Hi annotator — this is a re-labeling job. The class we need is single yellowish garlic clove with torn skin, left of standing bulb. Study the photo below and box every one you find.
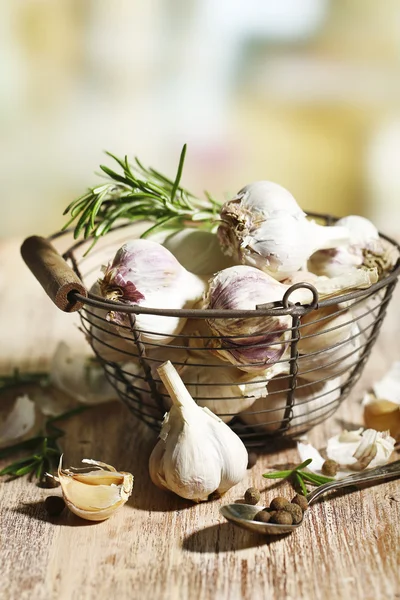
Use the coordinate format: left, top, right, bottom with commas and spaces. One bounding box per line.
55, 457, 133, 521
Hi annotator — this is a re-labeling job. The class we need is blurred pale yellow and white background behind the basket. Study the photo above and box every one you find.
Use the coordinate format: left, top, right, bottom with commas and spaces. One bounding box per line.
0, 0, 400, 237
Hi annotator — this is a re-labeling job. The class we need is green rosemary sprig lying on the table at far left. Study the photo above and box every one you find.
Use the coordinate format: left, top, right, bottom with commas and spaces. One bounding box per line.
0, 406, 90, 482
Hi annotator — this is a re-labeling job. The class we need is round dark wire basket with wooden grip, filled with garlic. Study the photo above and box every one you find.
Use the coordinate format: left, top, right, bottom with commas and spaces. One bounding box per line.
21, 214, 400, 447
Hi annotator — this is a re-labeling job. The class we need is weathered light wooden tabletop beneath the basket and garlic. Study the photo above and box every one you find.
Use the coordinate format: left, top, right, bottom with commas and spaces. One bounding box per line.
0, 240, 400, 600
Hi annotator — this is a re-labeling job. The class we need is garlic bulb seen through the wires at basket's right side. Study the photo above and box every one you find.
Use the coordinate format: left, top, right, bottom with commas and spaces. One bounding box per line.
297, 322, 361, 381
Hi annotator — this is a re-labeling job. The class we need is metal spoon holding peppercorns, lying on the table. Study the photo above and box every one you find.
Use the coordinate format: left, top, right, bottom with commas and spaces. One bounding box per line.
220, 460, 400, 535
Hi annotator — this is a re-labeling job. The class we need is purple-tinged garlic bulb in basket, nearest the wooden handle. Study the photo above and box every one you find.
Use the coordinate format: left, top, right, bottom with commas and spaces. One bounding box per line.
99, 239, 205, 344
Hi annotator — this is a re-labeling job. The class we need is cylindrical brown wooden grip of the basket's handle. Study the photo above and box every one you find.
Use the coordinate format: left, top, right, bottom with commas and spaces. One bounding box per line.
21, 235, 88, 312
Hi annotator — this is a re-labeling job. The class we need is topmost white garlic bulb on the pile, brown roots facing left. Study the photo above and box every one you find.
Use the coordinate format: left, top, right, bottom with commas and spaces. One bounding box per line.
218, 181, 350, 281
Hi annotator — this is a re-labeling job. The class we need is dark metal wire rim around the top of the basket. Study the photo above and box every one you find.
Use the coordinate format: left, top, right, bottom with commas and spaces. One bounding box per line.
48, 212, 400, 319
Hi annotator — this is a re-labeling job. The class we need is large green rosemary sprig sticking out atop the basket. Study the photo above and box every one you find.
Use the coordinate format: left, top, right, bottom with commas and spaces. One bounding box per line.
63, 144, 220, 254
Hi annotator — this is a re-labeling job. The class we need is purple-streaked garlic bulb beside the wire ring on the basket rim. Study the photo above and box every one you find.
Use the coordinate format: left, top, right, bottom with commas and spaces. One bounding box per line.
204, 265, 377, 371
